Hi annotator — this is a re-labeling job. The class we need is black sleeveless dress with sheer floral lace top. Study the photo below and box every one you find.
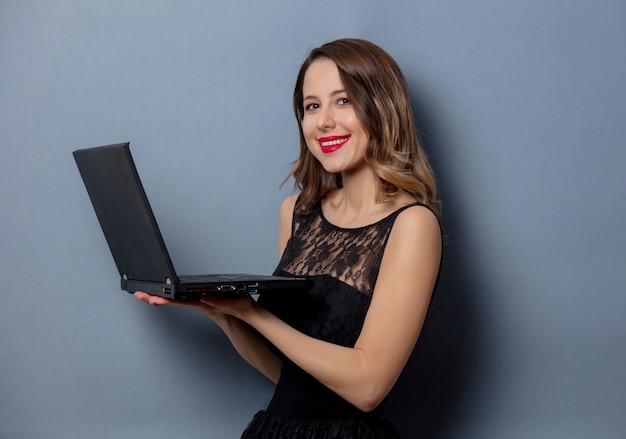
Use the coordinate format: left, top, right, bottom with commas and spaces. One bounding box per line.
241, 203, 421, 439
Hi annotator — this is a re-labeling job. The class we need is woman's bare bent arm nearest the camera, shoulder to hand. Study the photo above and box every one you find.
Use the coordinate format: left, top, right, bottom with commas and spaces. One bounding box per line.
203, 203, 441, 411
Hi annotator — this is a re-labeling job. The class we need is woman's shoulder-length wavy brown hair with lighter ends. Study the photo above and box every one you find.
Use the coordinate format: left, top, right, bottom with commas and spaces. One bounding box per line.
285, 38, 439, 217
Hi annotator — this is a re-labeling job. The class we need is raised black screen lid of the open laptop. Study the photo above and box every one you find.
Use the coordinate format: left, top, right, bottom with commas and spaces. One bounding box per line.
73, 143, 178, 283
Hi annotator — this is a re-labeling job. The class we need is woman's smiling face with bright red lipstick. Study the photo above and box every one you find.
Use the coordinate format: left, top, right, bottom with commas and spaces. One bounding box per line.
302, 59, 369, 174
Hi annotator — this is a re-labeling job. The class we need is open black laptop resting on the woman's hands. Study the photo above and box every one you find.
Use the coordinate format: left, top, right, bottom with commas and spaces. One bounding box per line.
73, 143, 312, 300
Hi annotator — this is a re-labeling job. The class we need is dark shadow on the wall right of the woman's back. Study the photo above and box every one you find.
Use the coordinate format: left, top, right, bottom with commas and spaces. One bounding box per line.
386, 87, 481, 438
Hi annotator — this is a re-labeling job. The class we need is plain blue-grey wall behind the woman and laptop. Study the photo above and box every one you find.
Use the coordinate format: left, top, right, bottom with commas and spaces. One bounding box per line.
0, 0, 626, 439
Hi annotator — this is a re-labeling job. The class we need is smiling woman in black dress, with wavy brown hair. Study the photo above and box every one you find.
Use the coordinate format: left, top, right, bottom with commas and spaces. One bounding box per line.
135, 39, 442, 439
